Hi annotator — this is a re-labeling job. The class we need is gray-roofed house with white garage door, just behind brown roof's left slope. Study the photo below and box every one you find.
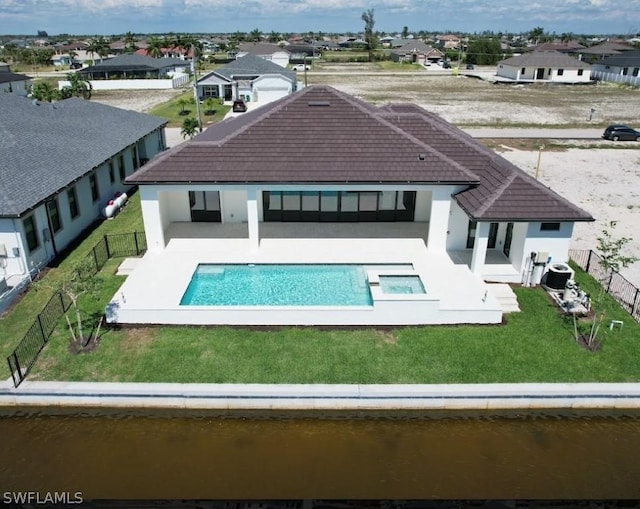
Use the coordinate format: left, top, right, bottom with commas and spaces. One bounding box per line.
196, 55, 299, 104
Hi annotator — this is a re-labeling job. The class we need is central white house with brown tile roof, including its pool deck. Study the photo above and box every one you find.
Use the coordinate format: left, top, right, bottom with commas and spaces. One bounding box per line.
109, 86, 593, 325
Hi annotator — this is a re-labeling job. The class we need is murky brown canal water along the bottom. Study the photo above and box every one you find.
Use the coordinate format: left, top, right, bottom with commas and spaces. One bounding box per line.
0, 409, 640, 499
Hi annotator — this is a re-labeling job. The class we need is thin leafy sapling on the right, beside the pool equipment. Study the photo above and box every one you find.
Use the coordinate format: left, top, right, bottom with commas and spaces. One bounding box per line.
574, 221, 638, 350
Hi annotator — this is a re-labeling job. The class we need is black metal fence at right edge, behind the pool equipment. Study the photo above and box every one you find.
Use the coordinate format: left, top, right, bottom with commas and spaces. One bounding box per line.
569, 249, 640, 322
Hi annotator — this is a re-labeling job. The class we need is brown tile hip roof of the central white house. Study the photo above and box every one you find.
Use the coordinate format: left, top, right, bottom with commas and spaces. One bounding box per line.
127, 86, 593, 221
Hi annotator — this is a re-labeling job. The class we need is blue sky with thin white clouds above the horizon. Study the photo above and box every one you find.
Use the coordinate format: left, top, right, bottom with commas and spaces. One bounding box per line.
0, 0, 640, 35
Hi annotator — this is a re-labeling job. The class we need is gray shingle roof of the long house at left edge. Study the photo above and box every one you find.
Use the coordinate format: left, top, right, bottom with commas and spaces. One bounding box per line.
0, 94, 166, 217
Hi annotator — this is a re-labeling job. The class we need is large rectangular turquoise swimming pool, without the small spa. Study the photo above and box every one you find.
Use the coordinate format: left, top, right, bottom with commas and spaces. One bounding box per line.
180, 264, 373, 306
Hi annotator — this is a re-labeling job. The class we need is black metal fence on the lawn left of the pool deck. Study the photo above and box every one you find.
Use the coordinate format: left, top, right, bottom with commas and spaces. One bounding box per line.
7, 232, 147, 387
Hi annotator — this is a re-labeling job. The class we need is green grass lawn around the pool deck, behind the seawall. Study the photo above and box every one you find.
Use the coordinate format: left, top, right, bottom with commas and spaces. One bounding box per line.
5, 193, 640, 383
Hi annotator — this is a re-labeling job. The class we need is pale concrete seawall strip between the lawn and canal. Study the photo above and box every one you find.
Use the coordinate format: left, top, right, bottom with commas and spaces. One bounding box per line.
0, 379, 640, 411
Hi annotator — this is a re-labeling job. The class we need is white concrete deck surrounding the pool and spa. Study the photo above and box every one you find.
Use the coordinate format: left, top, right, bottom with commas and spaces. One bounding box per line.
108, 223, 504, 326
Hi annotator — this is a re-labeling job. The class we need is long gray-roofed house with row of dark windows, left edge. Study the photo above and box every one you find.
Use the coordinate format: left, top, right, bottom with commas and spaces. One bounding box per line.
0, 94, 166, 308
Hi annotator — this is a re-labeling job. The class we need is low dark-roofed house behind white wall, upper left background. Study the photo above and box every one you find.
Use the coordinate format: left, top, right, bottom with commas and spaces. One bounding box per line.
78, 54, 191, 80
